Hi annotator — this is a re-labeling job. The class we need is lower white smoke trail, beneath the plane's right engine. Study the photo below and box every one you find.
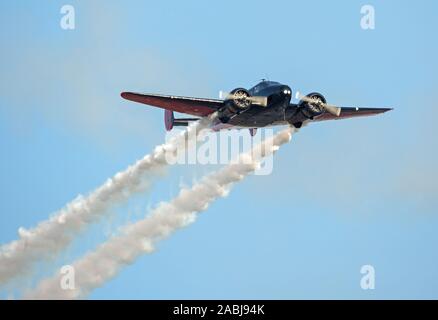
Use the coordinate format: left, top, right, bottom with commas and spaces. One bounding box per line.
24, 128, 295, 299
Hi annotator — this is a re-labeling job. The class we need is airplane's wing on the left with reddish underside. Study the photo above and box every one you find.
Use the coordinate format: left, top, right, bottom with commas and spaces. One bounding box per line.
121, 92, 224, 117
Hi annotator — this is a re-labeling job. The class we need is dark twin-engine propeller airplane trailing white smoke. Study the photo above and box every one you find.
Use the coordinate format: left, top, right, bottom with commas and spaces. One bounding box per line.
121, 79, 392, 136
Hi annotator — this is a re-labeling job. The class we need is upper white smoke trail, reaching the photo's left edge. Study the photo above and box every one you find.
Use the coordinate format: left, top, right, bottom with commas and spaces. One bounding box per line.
0, 115, 214, 285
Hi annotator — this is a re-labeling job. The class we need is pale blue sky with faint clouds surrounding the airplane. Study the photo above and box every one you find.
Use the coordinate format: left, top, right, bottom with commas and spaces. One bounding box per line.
0, 1, 438, 299
